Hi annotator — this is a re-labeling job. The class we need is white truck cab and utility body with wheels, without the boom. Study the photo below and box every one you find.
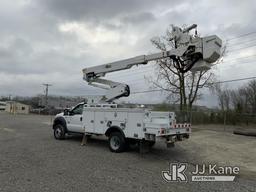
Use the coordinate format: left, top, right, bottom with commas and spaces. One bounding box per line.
53, 103, 191, 152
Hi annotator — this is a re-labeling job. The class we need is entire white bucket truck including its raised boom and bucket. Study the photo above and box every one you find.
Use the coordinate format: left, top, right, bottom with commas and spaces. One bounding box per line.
53, 25, 222, 152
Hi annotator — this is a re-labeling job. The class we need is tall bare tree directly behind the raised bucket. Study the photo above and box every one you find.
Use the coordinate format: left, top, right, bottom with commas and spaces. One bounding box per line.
150, 26, 221, 111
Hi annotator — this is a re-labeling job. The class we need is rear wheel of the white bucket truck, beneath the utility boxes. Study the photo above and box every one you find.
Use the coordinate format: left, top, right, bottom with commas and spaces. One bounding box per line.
108, 132, 126, 153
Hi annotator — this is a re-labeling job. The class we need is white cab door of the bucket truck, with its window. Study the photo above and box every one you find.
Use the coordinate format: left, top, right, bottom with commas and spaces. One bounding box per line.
67, 104, 84, 133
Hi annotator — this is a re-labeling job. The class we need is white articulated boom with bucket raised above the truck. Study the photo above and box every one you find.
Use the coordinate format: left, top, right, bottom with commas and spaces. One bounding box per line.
83, 24, 222, 102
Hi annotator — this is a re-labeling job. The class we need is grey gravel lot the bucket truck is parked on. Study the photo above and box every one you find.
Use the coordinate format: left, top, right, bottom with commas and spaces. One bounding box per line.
0, 113, 256, 192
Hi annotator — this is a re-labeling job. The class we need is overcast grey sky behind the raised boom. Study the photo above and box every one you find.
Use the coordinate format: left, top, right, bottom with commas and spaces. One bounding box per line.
0, 0, 256, 105
